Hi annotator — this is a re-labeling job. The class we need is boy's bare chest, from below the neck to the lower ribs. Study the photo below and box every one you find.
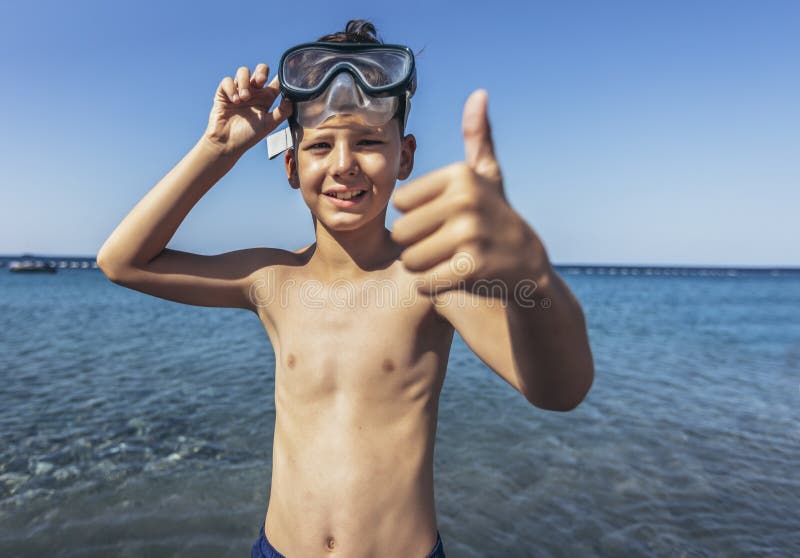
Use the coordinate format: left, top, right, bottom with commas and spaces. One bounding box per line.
253, 270, 453, 402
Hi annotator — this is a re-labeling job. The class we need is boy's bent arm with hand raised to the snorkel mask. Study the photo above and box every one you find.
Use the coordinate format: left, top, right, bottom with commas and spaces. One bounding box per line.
97, 64, 290, 316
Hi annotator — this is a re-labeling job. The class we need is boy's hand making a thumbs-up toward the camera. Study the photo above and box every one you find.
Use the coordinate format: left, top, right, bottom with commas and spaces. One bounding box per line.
392, 90, 550, 294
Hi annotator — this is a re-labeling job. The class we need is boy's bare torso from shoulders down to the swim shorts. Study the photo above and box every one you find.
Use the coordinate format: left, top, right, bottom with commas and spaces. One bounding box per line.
252, 247, 453, 558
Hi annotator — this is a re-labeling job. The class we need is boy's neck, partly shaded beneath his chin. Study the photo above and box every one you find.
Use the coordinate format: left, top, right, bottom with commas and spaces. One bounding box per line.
311, 209, 402, 281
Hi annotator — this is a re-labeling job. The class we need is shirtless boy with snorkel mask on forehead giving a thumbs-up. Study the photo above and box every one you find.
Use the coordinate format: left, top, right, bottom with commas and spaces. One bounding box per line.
97, 20, 593, 558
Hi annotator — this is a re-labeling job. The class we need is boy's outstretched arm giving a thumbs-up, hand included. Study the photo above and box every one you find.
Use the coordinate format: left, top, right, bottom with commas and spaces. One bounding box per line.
392, 92, 594, 411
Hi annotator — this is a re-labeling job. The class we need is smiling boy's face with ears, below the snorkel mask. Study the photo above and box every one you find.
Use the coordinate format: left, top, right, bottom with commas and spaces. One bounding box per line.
284, 114, 416, 231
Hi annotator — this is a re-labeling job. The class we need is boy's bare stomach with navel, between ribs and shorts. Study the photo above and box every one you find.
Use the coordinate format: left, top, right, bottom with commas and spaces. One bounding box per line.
265, 397, 444, 556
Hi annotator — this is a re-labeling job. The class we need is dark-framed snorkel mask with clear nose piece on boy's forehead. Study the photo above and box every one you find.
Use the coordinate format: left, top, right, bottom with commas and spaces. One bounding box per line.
267, 42, 417, 159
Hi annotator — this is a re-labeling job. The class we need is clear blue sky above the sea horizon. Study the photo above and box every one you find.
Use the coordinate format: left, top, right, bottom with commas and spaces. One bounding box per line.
0, 0, 800, 265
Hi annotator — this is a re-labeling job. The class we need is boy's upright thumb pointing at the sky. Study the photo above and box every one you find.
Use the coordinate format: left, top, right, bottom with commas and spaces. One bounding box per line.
461, 89, 500, 180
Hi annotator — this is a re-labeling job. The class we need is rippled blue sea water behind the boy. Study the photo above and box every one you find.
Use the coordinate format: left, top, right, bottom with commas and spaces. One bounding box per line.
0, 269, 800, 558
